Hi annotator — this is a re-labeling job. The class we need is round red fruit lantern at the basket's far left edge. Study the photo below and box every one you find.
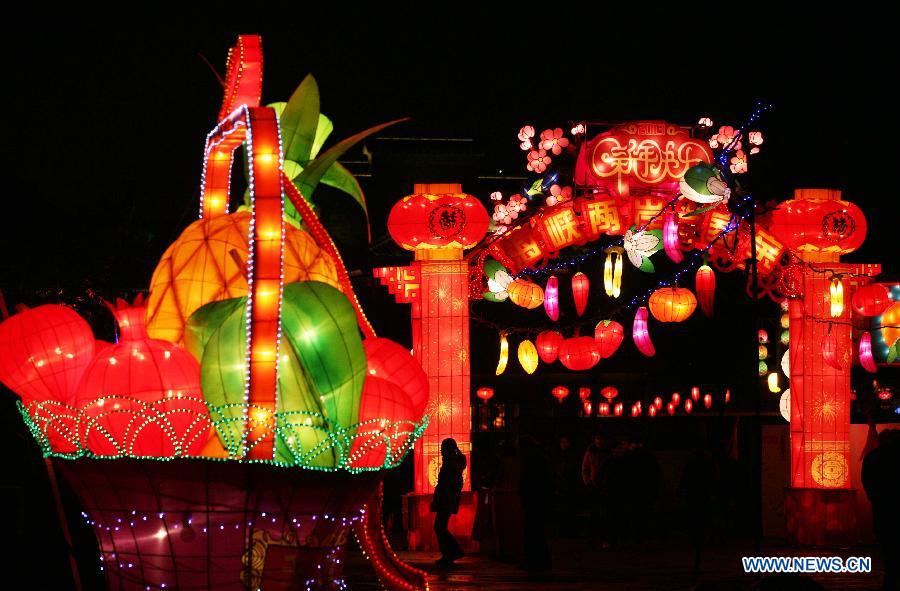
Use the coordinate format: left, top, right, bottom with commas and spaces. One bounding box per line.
0, 304, 95, 407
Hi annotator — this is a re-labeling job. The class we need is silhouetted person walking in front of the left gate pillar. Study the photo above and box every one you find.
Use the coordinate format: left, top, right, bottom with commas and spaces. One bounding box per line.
431, 437, 466, 565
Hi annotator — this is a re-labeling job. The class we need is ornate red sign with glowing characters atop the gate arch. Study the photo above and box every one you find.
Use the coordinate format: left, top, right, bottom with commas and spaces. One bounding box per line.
575, 121, 713, 196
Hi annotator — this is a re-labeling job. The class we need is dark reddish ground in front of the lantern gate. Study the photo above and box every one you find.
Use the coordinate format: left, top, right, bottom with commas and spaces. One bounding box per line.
346, 540, 881, 591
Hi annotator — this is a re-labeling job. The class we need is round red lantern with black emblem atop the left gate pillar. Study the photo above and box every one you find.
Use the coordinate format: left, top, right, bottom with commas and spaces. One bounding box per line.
387, 193, 490, 250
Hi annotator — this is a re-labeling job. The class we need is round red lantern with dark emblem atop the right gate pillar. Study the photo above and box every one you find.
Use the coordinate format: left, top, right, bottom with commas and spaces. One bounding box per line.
770, 189, 866, 261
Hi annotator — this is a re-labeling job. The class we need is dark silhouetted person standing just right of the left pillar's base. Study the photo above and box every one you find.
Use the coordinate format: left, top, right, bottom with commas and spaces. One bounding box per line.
519, 435, 552, 570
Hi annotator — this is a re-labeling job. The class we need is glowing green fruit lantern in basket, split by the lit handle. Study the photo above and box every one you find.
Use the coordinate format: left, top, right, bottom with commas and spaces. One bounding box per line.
185, 281, 366, 467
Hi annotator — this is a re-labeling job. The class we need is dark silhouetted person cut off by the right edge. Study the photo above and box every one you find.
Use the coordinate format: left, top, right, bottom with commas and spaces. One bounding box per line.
862, 429, 900, 590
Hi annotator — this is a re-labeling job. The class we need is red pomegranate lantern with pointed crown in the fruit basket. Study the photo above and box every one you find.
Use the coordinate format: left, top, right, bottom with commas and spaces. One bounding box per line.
75, 296, 209, 457
